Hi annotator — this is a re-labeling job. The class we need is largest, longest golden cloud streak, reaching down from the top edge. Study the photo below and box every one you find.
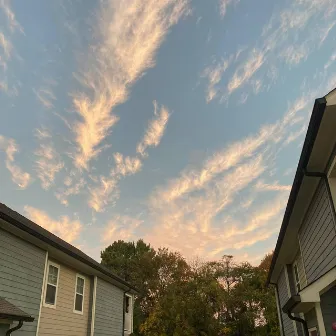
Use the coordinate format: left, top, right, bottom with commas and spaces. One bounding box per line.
73, 0, 188, 168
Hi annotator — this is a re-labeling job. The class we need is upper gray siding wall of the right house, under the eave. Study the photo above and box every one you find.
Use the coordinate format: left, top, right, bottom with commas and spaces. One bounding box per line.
299, 180, 336, 285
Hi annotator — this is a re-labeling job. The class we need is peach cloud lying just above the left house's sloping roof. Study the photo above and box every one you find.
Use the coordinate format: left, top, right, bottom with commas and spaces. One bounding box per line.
24, 205, 83, 243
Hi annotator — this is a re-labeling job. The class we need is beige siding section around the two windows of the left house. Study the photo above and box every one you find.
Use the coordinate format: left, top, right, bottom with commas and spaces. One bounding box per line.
39, 261, 92, 336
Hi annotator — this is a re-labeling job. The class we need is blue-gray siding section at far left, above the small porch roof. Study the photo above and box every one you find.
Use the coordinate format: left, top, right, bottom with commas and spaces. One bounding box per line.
0, 229, 46, 336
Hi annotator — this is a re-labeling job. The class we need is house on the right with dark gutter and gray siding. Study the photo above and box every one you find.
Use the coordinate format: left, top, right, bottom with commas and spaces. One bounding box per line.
268, 89, 336, 336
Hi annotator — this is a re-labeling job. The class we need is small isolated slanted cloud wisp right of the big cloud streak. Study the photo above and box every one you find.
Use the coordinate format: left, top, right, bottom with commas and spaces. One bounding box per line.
137, 101, 170, 156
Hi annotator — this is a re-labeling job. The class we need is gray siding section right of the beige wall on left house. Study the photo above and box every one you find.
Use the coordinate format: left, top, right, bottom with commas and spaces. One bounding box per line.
94, 278, 124, 336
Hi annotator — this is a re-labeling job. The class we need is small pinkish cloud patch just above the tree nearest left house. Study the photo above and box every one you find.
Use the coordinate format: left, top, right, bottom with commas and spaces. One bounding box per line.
101, 215, 143, 244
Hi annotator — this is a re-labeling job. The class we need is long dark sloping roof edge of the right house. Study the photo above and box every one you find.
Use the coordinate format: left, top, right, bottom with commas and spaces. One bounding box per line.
266, 97, 327, 285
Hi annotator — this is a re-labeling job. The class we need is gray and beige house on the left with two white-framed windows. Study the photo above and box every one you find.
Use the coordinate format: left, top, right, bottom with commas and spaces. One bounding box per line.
0, 204, 136, 336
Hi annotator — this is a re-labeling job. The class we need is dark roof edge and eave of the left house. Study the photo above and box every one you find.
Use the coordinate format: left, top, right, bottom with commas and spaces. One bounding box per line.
0, 203, 138, 292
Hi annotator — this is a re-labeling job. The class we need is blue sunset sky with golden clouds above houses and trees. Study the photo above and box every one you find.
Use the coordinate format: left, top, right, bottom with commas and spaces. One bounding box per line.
0, 0, 336, 264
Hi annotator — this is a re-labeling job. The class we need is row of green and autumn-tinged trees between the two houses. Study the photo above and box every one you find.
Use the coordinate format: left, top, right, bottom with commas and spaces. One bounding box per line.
101, 240, 280, 336
